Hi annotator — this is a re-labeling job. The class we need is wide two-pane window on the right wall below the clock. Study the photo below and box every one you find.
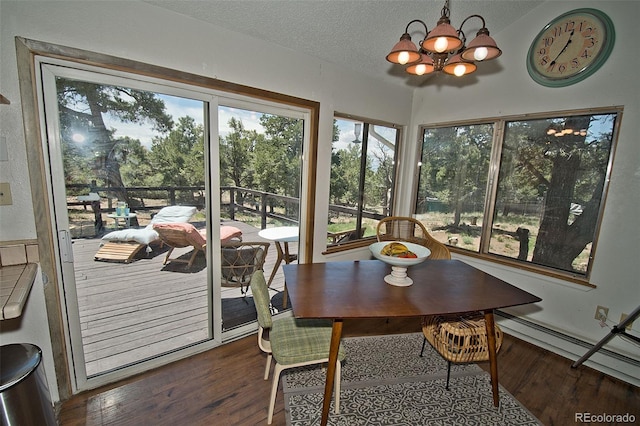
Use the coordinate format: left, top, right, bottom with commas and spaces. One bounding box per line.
414, 108, 622, 282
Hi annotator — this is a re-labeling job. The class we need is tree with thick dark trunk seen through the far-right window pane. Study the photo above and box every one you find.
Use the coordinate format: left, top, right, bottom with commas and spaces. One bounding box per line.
499, 115, 614, 271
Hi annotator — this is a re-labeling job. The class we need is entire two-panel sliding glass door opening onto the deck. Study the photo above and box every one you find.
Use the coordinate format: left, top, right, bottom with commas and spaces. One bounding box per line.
37, 59, 309, 390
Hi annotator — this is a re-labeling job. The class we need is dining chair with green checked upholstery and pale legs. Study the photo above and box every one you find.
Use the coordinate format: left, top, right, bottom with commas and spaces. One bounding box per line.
251, 271, 345, 424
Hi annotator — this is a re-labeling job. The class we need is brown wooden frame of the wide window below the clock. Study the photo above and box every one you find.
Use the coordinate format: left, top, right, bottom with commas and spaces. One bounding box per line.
411, 105, 624, 288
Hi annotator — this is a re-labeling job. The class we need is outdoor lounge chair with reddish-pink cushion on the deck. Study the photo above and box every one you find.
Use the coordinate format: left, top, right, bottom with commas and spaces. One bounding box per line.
153, 223, 242, 268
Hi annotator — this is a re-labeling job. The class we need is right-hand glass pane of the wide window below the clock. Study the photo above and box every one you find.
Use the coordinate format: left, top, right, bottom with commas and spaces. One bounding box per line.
489, 114, 616, 274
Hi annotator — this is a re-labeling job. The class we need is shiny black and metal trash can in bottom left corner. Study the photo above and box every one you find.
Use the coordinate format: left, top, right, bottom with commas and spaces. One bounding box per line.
0, 343, 57, 426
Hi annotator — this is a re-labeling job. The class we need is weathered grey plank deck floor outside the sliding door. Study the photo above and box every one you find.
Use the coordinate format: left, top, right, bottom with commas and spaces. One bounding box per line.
73, 221, 297, 376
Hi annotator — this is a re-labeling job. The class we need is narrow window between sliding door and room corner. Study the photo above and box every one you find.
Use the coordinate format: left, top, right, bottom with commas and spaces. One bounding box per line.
327, 115, 401, 246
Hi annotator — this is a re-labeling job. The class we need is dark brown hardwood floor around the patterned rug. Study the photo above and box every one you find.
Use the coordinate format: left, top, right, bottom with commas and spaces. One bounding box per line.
59, 319, 640, 426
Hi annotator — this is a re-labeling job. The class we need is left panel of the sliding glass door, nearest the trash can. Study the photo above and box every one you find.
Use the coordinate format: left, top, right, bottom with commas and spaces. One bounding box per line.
41, 64, 220, 388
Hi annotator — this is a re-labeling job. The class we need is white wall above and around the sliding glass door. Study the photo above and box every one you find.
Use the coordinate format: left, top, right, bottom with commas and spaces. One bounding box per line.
0, 0, 412, 400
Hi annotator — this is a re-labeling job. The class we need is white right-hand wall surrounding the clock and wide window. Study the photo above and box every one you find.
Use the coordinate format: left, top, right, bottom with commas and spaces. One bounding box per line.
411, 1, 640, 384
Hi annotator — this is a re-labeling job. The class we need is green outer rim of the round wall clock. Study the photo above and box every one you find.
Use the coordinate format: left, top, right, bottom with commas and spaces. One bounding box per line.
527, 8, 616, 87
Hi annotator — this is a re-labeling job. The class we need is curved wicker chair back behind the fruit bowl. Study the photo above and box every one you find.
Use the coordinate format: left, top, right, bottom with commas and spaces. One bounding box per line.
376, 216, 451, 259
